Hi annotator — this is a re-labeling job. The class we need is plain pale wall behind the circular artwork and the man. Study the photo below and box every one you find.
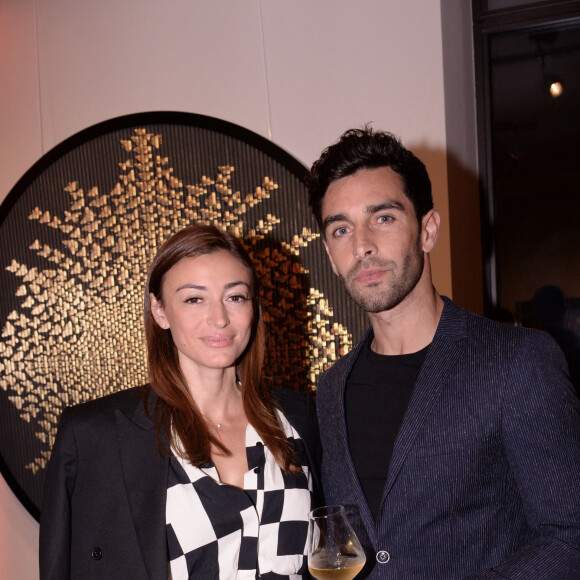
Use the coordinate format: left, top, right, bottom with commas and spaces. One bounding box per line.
0, 0, 473, 579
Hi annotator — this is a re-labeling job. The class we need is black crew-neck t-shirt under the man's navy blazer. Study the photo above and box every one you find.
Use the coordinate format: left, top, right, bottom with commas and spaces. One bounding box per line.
345, 335, 429, 519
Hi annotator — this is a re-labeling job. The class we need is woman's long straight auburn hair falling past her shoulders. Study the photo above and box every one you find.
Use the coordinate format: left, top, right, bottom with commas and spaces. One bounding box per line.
145, 224, 301, 473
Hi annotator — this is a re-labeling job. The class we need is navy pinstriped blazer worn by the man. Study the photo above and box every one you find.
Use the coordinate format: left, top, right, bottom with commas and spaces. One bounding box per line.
317, 298, 580, 580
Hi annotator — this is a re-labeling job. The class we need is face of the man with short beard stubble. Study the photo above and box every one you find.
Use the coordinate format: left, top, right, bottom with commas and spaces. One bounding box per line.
322, 167, 424, 313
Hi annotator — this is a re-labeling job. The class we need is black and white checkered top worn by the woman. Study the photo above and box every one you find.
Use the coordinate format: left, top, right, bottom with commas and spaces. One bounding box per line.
166, 411, 313, 580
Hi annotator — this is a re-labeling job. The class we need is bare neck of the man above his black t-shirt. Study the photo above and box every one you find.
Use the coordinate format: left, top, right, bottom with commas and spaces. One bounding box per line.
369, 286, 444, 355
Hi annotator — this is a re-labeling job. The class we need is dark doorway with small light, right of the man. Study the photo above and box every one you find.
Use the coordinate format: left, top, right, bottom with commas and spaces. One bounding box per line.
474, 1, 580, 390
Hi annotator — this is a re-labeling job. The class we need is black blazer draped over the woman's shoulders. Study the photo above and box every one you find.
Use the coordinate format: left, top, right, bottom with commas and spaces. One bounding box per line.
40, 388, 321, 580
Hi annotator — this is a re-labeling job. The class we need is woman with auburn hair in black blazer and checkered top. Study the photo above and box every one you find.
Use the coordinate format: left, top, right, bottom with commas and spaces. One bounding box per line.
40, 225, 320, 580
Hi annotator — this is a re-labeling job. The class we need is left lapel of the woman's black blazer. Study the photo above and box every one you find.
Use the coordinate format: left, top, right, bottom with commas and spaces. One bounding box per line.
116, 395, 169, 579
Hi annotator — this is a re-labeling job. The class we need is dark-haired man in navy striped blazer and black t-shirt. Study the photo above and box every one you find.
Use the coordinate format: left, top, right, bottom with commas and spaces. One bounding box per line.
309, 127, 580, 580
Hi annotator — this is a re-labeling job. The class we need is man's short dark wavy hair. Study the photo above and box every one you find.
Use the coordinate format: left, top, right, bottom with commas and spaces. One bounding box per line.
307, 125, 433, 233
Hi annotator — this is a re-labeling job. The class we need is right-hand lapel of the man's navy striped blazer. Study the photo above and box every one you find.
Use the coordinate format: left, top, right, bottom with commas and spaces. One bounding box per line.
381, 299, 467, 507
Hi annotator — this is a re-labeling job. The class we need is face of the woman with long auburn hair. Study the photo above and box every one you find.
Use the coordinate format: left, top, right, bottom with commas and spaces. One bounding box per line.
150, 250, 254, 376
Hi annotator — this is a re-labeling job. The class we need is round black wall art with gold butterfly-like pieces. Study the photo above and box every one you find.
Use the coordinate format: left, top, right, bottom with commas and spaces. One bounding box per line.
0, 112, 365, 519
